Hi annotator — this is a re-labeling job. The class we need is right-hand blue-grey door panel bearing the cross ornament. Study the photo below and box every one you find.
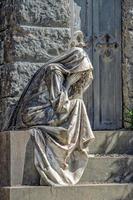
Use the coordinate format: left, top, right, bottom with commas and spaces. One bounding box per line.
93, 0, 122, 129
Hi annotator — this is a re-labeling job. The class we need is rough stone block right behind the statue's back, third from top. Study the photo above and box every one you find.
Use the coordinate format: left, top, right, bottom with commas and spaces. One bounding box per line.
0, 62, 44, 98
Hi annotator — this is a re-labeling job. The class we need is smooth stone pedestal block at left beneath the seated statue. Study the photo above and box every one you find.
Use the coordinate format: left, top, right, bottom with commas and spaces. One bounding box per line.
0, 131, 39, 186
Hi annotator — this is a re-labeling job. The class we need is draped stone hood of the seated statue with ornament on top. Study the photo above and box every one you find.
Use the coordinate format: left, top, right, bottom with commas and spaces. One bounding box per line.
46, 31, 93, 73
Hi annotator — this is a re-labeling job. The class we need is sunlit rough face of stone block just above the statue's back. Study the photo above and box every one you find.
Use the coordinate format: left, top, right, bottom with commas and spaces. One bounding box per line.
13, 26, 70, 62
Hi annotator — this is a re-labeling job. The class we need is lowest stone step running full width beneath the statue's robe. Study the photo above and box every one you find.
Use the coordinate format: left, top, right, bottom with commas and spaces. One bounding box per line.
0, 184, 133, 200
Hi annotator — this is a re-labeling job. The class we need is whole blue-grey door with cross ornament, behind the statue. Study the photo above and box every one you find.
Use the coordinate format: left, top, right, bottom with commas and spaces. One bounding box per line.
72, 0, 122, 130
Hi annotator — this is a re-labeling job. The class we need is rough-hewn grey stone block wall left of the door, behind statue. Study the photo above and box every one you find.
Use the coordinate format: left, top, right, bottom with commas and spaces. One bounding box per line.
0, 0, 71, 129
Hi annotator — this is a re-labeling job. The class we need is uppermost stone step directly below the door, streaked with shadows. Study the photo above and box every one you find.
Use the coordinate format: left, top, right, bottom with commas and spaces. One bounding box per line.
90, 130, 133, 155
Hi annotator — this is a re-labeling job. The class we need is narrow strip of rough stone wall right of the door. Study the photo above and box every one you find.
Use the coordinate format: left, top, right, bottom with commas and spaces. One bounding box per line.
122, 0, 133, 127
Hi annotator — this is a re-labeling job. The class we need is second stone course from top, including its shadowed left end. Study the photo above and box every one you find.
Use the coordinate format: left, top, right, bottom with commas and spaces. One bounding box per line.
0, 26, 71, 64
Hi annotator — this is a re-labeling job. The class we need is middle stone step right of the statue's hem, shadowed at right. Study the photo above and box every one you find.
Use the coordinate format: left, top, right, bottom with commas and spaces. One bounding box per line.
80, 155, 133, 183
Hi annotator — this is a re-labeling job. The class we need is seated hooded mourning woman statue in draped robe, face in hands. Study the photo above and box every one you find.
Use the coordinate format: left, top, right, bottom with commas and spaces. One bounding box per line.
5, 31, 94, 185
